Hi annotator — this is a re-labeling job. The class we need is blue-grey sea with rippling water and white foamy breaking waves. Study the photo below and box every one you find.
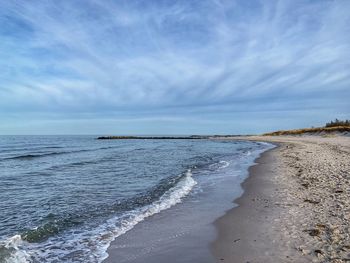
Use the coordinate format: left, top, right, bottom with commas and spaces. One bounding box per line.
0, 136, 273, 262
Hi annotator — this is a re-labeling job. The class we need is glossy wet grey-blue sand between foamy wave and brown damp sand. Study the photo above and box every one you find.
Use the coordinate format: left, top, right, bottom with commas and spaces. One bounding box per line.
103, 141, 273, 263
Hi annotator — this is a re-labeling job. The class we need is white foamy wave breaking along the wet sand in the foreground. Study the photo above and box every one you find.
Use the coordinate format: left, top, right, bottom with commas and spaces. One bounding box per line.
0, 170, 197, 263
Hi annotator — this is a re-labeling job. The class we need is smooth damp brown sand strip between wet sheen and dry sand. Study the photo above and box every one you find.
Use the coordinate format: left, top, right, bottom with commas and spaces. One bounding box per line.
210, 143, 308, 263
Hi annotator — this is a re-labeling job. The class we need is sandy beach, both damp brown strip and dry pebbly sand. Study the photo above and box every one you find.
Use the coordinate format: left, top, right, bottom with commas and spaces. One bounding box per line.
211, 136, 350, 263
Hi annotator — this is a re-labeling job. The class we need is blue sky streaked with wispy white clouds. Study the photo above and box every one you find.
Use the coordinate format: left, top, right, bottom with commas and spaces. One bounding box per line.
0, 0, 350, 135
